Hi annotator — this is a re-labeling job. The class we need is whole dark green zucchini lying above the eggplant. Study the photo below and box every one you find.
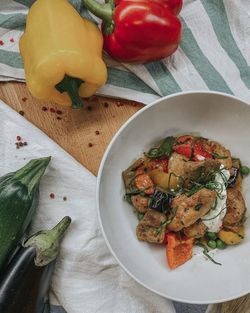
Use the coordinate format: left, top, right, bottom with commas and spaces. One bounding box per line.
0, 157, 51, 272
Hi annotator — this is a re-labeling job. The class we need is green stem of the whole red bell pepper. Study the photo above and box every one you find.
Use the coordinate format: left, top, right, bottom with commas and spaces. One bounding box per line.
82, 0, 114, 34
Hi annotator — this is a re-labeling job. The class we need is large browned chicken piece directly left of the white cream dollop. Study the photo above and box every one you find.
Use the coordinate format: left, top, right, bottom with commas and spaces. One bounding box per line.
167, 188, 217, 231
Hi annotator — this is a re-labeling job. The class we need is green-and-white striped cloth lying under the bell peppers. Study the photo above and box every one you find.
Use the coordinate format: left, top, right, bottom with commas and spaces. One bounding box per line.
0, 0, 250, 104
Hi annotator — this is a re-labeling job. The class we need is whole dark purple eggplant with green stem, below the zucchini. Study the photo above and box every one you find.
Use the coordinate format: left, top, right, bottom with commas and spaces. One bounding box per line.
0, 216, 71, 313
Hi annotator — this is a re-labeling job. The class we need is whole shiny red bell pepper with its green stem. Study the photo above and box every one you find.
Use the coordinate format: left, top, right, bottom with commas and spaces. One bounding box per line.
83, 0, 182, 63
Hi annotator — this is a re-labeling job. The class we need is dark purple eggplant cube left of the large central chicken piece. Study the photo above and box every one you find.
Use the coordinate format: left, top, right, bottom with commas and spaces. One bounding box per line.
149, 190, 172, 213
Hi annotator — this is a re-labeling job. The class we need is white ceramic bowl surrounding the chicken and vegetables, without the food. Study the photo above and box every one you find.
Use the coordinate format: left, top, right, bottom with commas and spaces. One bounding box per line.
97, 92, 250, 304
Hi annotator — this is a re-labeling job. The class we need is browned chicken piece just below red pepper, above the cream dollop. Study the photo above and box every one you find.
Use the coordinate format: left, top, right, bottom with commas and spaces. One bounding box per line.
168, 152, 220, 186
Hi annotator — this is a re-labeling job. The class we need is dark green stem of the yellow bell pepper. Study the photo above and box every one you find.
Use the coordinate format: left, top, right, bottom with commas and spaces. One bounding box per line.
55, 75, 84, 109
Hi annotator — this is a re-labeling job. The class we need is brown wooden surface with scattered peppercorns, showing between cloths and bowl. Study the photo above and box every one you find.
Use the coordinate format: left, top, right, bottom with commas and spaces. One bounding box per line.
0, 82, 250, 313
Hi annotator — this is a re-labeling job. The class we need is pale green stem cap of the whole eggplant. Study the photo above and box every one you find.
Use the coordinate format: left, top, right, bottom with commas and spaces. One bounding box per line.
23, 216, 71, 266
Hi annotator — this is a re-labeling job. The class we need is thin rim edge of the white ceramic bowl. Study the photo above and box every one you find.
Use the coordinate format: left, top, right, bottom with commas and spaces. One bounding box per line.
96, 90, 250, 304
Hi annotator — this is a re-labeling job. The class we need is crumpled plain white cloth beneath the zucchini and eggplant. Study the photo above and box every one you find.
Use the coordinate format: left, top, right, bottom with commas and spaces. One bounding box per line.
0, 101, 175, 313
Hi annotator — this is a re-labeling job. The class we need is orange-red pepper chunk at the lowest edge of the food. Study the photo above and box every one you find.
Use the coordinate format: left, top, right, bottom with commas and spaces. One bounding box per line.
166, 232, 194, 269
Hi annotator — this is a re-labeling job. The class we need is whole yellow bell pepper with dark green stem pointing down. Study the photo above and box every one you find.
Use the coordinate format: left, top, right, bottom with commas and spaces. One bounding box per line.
19, 0, 107, 108
